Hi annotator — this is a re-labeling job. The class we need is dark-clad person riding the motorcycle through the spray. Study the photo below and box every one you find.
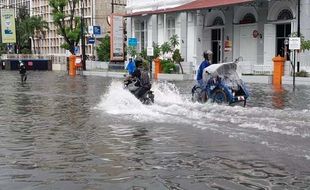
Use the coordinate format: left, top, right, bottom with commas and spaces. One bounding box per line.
131, 59, 152, 99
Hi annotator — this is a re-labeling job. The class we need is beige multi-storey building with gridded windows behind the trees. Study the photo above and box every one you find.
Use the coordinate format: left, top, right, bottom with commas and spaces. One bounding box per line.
0, 0, 126, 63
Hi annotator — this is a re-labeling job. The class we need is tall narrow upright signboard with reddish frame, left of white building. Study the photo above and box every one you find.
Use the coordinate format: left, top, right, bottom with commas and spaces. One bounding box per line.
110, 14, 124, 61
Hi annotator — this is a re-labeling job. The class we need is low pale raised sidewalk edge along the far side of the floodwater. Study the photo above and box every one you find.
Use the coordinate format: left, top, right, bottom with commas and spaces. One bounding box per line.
83, 70, 310, 85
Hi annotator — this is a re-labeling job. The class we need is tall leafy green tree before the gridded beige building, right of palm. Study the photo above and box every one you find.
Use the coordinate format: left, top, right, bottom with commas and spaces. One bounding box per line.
49, 0, 81, 54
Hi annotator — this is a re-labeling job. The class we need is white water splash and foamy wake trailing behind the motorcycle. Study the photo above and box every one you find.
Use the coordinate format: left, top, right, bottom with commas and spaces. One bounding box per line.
96, 81, 310, 160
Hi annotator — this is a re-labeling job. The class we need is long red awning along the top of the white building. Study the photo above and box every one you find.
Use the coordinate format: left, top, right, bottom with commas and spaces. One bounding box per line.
126, 0, 254, 17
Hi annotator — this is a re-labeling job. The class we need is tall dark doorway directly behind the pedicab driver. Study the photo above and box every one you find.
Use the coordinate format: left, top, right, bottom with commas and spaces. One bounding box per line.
211, 28, 222, 64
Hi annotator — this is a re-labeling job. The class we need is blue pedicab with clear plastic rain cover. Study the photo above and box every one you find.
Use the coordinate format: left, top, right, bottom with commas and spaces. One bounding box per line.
192, 61, 249, 106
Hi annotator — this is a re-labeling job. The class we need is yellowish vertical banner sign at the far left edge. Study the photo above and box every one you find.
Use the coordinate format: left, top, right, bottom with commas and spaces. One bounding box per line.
1, 9, 16, 43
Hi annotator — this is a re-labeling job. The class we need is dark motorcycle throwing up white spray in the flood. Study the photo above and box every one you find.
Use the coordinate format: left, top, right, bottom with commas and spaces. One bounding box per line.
124, 77, 154, 105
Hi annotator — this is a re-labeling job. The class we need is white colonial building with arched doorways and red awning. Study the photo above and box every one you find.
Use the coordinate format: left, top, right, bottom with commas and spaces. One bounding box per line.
126, 0, 310, 74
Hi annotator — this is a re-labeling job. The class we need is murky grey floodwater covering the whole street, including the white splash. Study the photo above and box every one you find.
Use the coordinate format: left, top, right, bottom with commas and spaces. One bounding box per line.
0, 71, 310, 190
